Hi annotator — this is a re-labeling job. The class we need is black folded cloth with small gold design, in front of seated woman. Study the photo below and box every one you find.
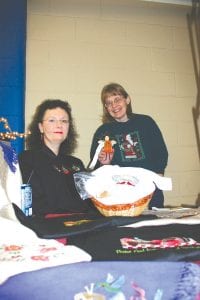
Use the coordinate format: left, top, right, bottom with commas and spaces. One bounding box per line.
13, 204, 157, 239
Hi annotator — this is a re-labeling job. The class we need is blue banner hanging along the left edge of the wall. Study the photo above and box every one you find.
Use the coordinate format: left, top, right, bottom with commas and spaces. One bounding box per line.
0, 0, 27, 153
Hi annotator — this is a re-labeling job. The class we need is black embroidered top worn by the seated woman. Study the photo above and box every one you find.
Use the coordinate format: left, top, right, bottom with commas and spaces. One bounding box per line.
19, 146, 95, 215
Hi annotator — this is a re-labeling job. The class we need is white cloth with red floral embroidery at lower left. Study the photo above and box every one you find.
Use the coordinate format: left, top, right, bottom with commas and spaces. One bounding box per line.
0, 218, 91, 283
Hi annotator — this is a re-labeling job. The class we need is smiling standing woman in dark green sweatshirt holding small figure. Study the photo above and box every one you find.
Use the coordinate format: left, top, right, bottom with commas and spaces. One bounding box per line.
90, 83, 168, 208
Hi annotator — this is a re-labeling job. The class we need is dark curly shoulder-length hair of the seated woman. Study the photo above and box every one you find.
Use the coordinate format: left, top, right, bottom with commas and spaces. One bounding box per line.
25, 99, 78, 155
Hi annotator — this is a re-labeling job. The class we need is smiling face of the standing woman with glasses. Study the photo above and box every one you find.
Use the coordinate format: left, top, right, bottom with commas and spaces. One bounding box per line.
105, 95, 130, 122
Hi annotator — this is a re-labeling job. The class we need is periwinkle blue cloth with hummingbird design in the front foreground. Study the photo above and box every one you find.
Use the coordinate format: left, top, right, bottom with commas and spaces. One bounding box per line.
0, 261, 200, 300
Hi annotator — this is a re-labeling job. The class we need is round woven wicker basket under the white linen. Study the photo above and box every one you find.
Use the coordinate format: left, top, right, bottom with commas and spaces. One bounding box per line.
92, 193, 153, 217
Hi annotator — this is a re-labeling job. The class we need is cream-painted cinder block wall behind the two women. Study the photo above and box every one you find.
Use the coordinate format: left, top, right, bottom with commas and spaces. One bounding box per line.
26, 0, 200, 205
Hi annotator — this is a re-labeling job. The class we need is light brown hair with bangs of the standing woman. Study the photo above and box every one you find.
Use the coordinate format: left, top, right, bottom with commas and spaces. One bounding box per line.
101, 82, 132, 123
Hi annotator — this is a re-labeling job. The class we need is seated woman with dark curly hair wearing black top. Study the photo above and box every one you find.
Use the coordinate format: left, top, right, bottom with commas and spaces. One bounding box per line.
19, 99, 97, 216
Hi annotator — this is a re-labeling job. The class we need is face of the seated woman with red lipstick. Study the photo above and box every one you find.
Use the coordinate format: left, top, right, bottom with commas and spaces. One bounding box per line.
39, 107, 69, 148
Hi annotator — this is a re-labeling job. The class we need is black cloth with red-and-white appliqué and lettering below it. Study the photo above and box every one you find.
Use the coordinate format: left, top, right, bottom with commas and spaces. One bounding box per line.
68, 220, 200, 261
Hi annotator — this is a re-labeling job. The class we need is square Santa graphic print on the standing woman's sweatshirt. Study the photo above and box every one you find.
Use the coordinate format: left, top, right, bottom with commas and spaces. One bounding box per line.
116, 131, 145, 161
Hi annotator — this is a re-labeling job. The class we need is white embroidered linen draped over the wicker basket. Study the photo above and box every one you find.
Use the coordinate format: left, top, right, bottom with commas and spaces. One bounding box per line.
78, 165, 172, 205
